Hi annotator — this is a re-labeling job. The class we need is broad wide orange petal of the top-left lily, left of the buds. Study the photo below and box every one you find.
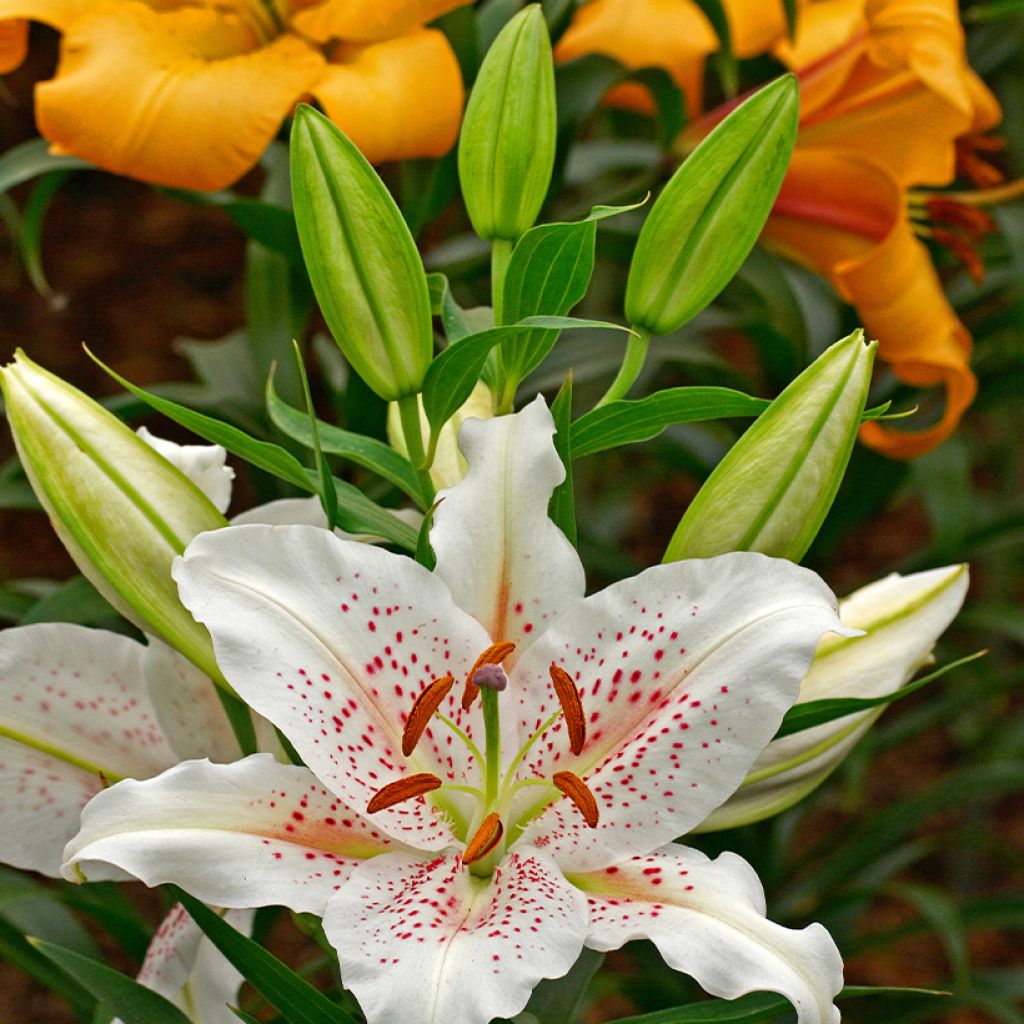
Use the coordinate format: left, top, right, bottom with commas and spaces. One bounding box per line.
36, 3, 324, 189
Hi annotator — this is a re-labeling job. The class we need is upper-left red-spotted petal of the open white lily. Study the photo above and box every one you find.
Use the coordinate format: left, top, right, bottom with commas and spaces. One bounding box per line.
174, 526, 489, 849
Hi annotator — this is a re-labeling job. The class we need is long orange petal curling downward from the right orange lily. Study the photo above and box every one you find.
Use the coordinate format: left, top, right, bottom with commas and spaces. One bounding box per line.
762, 152, 977, 459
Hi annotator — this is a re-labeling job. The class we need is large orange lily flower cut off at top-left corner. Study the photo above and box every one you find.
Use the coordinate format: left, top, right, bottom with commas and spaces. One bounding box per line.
0, 0, 468, 189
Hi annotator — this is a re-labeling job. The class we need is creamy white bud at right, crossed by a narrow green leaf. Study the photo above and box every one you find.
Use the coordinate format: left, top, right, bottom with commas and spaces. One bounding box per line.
697, 565, 968, 831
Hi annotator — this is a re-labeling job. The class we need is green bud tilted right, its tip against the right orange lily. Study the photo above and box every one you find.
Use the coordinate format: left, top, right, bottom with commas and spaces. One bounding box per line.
626, 75, 800, 334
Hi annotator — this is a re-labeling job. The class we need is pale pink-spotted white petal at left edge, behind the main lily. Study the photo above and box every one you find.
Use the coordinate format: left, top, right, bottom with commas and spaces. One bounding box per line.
0, 623, 177, 878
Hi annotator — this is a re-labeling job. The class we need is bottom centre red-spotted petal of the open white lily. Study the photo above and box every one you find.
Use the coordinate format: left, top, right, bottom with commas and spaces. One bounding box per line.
324, 847, 587, 1024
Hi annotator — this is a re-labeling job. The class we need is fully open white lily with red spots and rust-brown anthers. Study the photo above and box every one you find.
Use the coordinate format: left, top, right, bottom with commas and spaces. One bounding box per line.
65, 399, 851, 1024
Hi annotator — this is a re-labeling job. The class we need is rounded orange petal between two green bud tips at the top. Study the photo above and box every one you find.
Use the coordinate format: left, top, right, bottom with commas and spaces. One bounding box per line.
312, 29, 463, 163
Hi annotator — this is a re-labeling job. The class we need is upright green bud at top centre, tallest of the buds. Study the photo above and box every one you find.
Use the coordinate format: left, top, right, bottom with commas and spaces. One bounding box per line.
459, 4, 558, 242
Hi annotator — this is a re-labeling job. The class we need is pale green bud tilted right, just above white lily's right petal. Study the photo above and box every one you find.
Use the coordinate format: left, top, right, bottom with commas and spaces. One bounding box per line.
664, 331, 878, 562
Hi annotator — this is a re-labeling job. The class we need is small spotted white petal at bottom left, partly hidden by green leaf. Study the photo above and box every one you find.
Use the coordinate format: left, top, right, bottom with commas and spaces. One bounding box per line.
114, 903, 255, 1024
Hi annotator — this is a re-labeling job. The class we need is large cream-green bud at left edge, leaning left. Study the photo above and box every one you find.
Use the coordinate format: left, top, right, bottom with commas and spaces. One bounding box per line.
0, 351, 226, 679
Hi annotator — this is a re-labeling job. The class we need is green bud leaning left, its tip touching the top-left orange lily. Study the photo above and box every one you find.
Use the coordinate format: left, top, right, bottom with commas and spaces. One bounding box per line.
292, 106, 433, 400
